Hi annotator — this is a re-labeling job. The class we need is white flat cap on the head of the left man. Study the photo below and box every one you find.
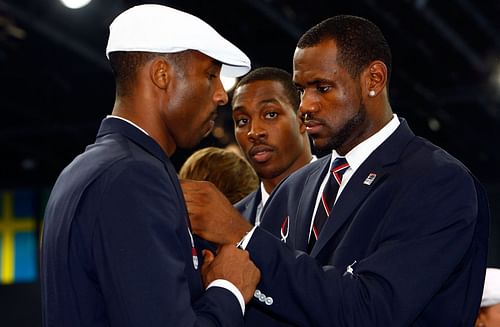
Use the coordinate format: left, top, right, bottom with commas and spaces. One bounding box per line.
106, 4, 251, 77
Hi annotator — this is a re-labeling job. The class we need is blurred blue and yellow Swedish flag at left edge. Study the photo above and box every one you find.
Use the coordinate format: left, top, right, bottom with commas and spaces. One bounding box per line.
0, 190, 38, 284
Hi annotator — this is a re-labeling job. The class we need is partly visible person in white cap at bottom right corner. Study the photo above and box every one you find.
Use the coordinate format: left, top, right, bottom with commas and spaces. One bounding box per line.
475, 267, 500, 327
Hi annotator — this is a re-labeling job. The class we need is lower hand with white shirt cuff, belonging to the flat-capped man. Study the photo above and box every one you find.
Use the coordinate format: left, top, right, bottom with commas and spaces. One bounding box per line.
201, 245, 260, 303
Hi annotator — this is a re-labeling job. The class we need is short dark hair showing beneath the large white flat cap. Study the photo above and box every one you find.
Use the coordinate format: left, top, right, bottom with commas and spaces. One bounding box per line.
109, 51, 187, 96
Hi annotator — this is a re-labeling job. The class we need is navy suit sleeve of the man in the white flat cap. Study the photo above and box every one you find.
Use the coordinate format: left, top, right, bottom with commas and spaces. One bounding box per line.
92, 163, 243, 327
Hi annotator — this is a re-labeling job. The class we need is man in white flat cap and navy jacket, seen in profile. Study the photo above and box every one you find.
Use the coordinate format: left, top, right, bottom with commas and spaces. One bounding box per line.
41, 5, 260, 327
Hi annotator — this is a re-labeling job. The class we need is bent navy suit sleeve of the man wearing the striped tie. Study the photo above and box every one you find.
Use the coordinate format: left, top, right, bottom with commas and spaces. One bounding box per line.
247, 160, 484, 327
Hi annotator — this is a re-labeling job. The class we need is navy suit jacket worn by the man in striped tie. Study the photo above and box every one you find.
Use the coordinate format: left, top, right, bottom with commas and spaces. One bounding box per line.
246, 120, 489, 327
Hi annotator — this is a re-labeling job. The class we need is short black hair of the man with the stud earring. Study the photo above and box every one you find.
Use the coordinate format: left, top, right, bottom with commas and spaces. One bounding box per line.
297, 15, 392, 83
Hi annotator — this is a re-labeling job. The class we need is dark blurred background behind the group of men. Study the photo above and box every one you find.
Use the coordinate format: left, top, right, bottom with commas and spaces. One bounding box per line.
0, 0, 500, 327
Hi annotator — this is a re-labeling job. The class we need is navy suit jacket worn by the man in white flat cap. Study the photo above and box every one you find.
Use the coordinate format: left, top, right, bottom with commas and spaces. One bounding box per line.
41, 118, 243, 327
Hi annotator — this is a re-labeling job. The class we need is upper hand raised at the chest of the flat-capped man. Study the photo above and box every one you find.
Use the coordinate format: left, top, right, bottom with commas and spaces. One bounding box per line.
181, 180, 253, 245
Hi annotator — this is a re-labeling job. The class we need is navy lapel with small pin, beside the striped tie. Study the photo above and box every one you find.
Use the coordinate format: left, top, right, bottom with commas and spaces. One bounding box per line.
311, 120, 415, 257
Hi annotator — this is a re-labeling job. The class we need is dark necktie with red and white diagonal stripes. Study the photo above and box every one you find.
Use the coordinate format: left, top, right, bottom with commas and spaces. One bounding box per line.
307, 157, 349, 253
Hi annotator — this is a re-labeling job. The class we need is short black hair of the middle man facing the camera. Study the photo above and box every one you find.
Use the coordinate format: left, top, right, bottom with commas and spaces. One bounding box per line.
233, 67, 300, 113
